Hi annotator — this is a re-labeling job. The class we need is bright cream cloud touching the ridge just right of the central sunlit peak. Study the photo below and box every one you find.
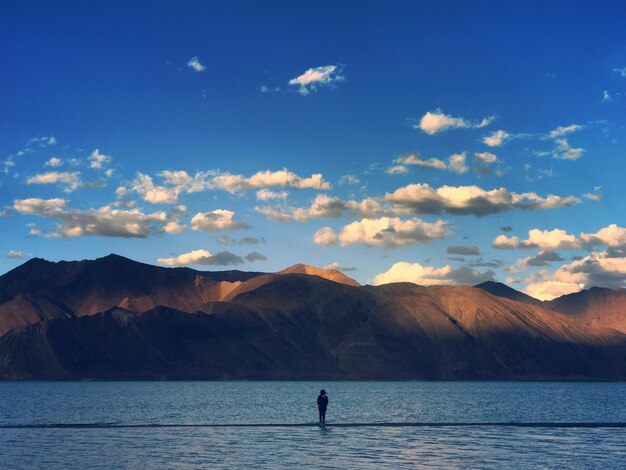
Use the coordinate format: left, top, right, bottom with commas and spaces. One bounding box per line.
374, 261, 494, 286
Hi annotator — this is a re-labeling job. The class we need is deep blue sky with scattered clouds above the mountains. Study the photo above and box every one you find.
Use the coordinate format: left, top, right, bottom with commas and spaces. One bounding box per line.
0, 1, 626, 299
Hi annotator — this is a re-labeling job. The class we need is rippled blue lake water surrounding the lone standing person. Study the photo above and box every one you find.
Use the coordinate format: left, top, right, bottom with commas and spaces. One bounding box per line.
0, 382, 626, 469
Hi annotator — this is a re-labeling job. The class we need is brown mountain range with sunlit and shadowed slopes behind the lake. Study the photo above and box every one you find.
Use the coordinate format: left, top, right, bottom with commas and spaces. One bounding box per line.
0, 255, 626, 380
